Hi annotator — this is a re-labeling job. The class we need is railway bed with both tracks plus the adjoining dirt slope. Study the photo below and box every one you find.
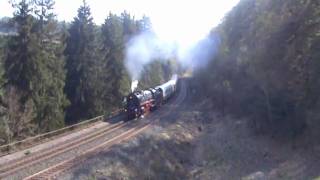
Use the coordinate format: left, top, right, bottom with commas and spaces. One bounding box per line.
0, 78, 320, 179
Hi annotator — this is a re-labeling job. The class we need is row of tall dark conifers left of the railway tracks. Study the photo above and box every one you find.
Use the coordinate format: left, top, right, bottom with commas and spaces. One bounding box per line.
0, 0, 172, 144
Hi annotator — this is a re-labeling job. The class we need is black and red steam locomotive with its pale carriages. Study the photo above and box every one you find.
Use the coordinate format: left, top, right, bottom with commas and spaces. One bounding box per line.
125, 76, 177, 120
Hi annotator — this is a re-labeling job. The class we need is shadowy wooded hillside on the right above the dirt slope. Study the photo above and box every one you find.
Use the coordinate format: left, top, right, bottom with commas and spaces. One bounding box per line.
197, 0, 320, 137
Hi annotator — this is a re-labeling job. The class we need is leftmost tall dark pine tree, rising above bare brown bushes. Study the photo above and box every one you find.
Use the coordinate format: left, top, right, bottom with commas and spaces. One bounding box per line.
5, 0, 37, 95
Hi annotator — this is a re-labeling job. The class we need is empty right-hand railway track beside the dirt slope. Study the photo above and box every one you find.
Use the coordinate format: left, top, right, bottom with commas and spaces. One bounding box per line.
25, 123, 150, 180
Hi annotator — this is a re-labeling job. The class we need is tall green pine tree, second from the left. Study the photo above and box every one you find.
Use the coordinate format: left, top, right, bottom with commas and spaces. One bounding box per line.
33, 0, 68, 131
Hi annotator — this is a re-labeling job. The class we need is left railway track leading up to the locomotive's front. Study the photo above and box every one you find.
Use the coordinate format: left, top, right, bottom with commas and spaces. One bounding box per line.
0, 119, 126, 179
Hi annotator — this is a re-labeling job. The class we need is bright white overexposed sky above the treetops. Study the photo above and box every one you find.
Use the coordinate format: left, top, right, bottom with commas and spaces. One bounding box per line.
0, 0, 239, 45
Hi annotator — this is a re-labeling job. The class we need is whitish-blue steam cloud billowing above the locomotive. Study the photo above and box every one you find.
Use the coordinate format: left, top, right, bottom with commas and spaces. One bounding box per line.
125, 32, 220, 82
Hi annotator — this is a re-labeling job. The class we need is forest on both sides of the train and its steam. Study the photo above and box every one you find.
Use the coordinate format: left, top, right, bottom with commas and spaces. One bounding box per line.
0, 0, 320, 144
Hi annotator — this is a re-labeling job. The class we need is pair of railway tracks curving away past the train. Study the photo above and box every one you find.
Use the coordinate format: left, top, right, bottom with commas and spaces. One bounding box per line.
0, 80, 187, 179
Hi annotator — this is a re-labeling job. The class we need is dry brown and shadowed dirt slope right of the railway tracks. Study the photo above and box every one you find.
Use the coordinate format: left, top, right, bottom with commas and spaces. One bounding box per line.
59, 80, 320, 180
